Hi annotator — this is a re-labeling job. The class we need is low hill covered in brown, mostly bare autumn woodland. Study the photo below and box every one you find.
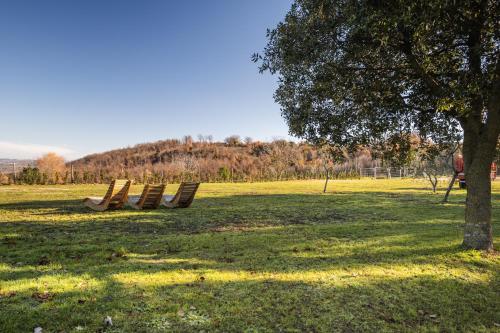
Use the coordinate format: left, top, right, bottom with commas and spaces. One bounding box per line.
67, 136, 372, 183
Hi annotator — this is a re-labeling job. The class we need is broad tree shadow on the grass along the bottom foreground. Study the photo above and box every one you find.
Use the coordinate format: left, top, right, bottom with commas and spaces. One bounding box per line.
0, 268, 498, 332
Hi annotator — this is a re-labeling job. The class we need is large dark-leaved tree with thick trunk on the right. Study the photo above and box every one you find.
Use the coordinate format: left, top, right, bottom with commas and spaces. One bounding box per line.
254, 0, 500, 249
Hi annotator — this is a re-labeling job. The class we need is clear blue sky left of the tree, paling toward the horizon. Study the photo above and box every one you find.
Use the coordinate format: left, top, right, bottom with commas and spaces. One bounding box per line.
0, 0, 291, 158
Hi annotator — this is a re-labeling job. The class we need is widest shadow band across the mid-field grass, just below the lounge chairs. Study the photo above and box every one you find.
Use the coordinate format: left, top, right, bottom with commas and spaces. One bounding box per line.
0, 192, 474, 279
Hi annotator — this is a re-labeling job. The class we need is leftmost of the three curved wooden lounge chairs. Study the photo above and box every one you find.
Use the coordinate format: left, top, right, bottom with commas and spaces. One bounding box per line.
83, 179, 131, 212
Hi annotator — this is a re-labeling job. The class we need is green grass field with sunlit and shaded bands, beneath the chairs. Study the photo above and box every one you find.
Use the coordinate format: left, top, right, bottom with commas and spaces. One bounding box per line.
0, 180, 500, 333
